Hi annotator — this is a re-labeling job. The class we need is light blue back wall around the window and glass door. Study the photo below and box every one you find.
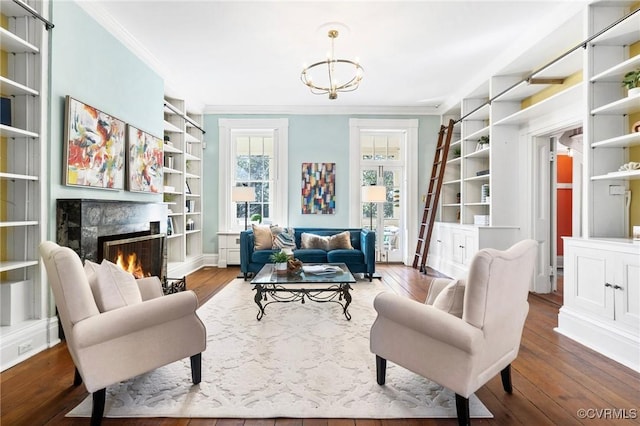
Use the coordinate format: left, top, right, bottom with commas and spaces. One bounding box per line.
203, 115, 440, 253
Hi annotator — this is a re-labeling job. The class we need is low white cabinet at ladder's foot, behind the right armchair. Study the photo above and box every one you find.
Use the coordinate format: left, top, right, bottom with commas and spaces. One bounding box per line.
427, 222, 518, 278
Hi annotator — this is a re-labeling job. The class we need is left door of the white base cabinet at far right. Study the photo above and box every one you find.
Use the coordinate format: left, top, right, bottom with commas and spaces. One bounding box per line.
565, 247, 614, 319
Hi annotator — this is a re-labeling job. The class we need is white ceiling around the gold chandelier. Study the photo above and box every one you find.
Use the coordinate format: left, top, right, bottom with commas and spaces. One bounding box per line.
79, 0, 586, 113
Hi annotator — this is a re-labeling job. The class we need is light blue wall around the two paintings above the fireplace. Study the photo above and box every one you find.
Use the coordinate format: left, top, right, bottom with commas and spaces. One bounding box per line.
48, 1, 164, 238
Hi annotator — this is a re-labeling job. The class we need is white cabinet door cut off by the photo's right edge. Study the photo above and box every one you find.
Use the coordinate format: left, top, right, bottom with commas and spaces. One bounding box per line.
612, 253, 640, 332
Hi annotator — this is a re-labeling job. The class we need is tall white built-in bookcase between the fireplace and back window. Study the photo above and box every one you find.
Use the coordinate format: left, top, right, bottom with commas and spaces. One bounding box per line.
164, 97, 204, 276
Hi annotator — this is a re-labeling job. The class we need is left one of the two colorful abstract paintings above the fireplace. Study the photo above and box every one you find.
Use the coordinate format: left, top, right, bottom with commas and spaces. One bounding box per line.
64, 96, 125, 189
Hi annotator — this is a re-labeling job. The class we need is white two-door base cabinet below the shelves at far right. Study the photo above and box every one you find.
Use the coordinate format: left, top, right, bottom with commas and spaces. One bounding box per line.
556, 238, 640, 371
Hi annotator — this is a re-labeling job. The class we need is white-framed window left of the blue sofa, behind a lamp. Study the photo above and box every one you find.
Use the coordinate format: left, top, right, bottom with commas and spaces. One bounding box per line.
218, 118, 288, 231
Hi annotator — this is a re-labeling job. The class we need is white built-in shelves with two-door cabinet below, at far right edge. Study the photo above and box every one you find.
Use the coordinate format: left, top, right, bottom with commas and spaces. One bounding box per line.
556, 2, 640, 371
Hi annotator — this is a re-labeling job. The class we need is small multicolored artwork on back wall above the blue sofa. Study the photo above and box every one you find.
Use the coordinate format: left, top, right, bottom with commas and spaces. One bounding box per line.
302, 163, 336, 214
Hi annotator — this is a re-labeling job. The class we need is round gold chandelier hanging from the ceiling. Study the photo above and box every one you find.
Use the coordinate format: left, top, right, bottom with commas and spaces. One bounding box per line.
300, 30, 364, 99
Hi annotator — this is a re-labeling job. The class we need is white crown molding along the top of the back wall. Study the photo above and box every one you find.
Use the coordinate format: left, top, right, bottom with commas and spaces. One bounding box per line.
203, 105, 442, 115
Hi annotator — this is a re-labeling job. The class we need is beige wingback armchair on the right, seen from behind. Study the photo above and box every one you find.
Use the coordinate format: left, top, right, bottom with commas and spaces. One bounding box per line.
370, 240, 537, 425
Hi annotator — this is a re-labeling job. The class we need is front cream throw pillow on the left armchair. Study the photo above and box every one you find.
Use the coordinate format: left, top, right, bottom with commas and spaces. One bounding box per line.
89, 259, 142, 312
